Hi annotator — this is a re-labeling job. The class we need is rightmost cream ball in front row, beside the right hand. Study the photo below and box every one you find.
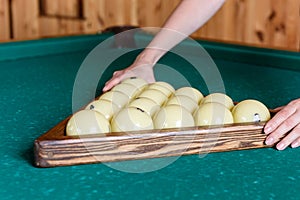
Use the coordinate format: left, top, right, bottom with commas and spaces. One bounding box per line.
232, 99, 271, 123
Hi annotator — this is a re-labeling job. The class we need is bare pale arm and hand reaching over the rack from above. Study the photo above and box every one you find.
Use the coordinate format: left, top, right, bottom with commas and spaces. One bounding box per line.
103, 0, 225, 92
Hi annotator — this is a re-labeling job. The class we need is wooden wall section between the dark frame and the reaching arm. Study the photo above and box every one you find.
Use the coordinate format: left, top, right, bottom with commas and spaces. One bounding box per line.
84, 0, 180, 32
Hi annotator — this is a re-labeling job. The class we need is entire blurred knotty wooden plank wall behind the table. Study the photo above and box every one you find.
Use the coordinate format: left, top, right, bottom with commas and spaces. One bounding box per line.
0, 0, 300, 51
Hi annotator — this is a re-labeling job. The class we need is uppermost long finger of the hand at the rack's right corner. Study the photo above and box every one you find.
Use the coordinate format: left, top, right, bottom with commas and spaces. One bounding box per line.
264, 104, 297, 134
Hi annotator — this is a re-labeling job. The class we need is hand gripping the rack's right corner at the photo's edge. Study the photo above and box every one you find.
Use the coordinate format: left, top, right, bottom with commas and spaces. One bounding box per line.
264, 99, 300, 150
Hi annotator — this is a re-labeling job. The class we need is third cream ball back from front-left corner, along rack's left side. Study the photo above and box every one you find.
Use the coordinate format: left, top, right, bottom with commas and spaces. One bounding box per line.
99, 91, 130, 108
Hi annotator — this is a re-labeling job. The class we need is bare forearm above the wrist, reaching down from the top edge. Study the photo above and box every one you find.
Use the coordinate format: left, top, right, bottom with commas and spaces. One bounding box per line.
136, 0, 225, 65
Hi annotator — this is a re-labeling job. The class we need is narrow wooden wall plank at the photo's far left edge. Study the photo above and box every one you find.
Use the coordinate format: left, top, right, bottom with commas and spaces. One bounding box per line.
0, 0, 10, 40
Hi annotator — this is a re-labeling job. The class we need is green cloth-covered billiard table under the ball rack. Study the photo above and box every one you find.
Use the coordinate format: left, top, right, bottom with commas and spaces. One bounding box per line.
0, 30, 300, 200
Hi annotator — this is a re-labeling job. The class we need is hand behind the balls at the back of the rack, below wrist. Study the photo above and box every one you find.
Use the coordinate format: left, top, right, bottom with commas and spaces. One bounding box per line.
103, 61, 155, 92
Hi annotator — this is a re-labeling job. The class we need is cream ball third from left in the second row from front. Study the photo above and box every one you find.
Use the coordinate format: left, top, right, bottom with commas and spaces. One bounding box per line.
166, 95, 198, 114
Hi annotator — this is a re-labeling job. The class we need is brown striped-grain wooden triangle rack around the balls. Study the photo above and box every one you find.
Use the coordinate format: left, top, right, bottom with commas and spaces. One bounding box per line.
34, 111, 270, 167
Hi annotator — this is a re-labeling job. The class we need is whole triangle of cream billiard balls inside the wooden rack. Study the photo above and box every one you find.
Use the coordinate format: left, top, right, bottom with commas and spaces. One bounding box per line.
66, 77, 270, 135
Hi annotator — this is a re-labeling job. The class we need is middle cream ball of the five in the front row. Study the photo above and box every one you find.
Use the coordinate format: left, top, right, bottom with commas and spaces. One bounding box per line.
153, 105, 195, 129
